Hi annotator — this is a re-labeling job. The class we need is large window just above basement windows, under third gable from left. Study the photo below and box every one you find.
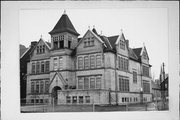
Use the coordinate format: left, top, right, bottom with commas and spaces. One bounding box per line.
119, 76, 129, 92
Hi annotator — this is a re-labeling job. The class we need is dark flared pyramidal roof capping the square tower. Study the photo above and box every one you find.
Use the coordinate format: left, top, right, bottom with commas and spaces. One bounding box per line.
49, 14, 79, 36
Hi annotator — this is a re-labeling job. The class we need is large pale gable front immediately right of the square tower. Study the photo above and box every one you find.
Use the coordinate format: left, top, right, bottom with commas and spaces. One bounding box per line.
76, 29, 106, 53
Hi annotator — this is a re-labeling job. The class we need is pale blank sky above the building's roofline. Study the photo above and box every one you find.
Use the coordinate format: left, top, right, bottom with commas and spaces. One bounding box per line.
19, 8, 168, 79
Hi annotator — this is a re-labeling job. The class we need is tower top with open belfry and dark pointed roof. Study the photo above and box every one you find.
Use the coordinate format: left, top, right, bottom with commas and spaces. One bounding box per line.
49, 11, 79, 50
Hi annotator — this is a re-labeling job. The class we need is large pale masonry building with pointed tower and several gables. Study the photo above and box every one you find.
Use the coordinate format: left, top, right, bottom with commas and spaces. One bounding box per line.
26, 13, 152, 104
